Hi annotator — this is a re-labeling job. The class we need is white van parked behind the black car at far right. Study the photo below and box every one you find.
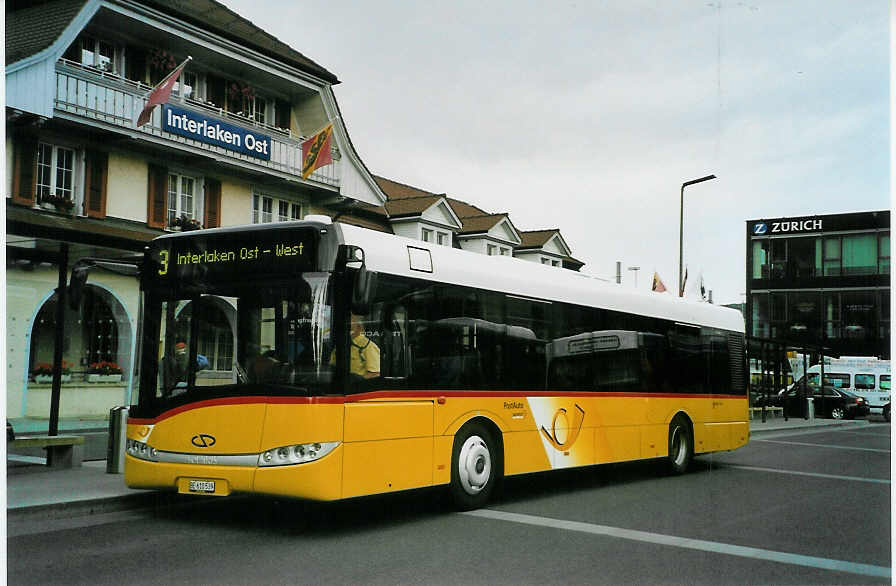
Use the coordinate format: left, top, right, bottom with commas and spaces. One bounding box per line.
788, 356, 890, 421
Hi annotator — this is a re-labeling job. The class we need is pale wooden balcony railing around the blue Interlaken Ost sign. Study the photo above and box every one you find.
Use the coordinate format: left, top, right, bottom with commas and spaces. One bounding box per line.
55, 59, 340, 187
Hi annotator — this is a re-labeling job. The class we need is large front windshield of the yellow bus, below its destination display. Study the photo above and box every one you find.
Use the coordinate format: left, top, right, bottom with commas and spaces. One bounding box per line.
140, 272, 333, 408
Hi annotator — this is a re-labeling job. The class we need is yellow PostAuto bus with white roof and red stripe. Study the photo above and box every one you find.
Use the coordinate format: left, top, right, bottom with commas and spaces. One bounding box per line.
125, 217, 749, 509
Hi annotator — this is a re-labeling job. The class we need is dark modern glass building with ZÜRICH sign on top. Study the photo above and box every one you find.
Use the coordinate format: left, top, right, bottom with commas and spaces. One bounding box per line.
745, 210, 890, 358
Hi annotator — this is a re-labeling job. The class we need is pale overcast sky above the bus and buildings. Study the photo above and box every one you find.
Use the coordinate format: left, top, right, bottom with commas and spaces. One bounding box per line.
223, 0, 891, 303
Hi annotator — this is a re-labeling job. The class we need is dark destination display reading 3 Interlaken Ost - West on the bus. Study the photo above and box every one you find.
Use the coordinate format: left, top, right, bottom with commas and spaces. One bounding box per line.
153, 230, 316, 281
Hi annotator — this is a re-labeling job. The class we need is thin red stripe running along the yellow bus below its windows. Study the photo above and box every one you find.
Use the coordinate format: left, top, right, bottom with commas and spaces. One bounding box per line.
128, 391, 747, 425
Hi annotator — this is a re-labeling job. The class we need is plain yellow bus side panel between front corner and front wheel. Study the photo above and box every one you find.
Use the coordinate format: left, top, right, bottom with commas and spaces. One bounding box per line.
342, 400, 433, 498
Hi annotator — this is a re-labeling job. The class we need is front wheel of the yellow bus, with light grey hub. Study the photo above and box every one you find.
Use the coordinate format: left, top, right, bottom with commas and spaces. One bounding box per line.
451, 421, 499, 511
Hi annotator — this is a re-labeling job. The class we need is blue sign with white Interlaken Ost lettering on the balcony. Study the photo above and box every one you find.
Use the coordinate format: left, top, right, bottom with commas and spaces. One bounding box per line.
162, 104, 271, 161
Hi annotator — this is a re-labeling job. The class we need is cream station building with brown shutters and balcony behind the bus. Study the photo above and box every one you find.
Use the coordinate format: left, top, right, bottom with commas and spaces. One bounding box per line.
5, 0, 582, 431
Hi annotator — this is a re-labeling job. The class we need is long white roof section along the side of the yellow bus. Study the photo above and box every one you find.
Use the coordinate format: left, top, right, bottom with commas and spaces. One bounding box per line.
334, 223, 744, 333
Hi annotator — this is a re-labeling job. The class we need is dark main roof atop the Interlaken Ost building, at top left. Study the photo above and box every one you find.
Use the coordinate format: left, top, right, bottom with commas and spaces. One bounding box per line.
6, 0, 339, 84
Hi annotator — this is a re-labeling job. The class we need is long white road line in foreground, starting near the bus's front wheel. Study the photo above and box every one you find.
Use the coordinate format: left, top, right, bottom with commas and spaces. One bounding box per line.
463, 509, 891, 578
